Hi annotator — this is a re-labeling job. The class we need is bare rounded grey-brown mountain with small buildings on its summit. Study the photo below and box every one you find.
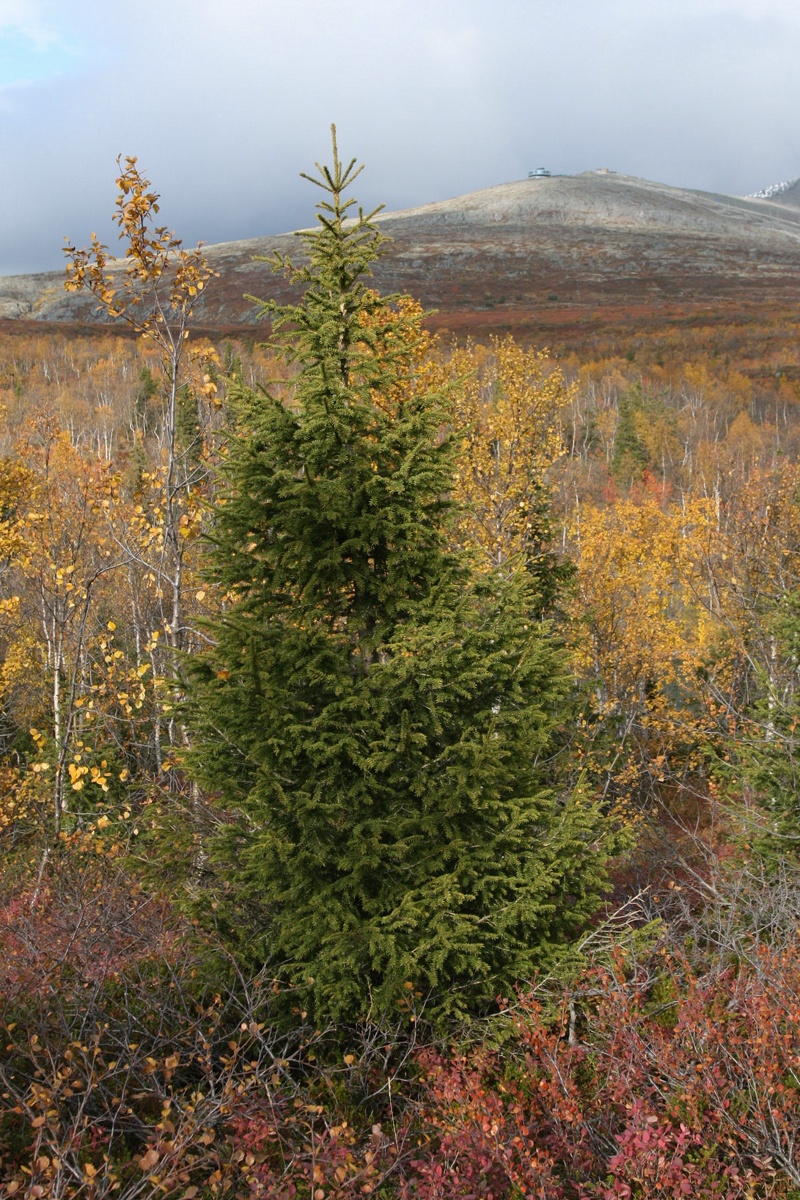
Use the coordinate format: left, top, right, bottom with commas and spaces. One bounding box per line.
0, 169, 800, 328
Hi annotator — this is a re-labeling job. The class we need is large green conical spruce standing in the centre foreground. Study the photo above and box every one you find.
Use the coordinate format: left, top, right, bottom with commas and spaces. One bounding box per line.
188, 132, 604, 1020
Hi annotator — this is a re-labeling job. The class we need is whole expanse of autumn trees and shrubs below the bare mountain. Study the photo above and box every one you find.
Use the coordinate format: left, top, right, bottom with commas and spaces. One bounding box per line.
0, 142, 800, 1200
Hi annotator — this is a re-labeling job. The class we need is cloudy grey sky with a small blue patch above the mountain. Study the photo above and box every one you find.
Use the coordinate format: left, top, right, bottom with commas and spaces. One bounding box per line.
0, 0, 800, 275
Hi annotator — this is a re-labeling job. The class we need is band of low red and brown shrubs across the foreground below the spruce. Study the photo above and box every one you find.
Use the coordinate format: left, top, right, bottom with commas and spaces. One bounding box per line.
9, 847, 800, 1200
